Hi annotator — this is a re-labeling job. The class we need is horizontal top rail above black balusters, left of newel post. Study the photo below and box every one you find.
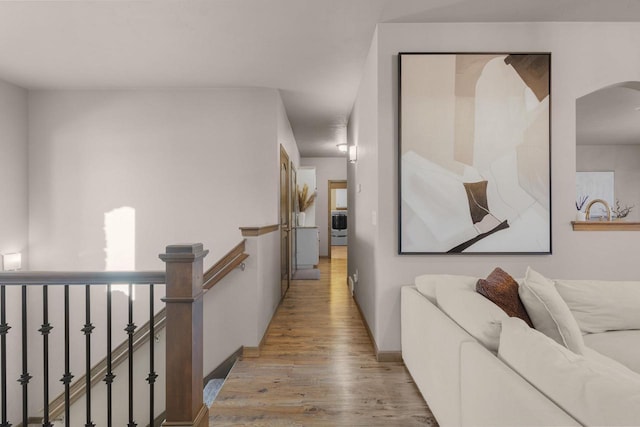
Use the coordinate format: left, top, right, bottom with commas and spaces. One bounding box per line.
0, 271, 166, 286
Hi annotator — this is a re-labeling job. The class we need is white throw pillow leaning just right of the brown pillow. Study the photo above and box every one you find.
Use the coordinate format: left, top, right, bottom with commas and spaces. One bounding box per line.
518, 267, 584, 354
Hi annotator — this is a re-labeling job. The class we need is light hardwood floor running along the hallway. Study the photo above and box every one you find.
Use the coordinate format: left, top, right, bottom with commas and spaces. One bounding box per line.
210, 259, 437, 427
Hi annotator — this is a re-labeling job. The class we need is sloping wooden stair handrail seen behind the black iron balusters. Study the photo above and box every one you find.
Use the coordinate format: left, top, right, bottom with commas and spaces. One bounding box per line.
49, 308, 167, 420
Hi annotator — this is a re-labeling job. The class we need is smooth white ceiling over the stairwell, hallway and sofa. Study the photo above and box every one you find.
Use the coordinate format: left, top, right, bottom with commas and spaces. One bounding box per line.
0, 0, 640, 157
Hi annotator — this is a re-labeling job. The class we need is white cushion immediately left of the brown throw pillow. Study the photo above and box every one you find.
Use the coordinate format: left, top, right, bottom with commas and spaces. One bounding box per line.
436, 276, 509, 352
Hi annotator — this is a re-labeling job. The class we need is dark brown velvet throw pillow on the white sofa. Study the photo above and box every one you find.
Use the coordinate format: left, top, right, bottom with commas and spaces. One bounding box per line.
476, 267, 533, 328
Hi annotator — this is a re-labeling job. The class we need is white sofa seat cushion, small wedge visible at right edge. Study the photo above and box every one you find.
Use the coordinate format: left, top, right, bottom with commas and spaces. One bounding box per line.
584, 330, 640, 374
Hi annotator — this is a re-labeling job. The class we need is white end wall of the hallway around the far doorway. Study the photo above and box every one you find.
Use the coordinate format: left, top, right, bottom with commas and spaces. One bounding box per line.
300, 157, 347, 256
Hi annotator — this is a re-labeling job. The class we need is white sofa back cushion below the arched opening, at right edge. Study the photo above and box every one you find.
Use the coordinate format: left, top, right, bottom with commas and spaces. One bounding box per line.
555, 280, 640, 334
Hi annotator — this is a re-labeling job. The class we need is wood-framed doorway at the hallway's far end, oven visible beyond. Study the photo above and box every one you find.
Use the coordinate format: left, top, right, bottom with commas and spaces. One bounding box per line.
327, 180, 348, 260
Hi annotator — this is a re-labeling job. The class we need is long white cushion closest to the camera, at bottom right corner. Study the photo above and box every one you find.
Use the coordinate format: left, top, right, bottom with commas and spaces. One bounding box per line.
498, 317, 640, 426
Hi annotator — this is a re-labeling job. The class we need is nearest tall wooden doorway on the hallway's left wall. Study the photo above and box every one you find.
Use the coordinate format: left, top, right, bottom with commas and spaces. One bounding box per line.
280, 145, 291, 298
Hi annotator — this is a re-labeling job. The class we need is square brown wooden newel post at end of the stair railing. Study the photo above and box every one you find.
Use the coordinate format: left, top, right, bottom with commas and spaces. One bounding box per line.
160, 243, 209, 427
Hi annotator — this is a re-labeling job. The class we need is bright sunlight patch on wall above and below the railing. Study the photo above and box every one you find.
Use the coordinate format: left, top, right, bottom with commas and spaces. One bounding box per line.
104, 206, 136, 298
